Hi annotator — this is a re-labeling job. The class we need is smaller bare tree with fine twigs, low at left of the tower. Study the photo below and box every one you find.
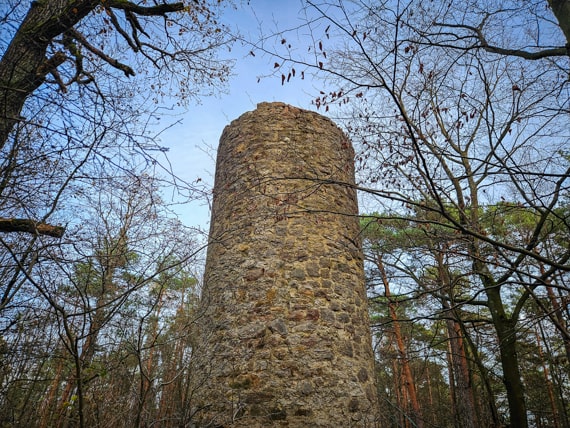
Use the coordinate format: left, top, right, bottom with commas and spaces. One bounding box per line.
0, 169, 201, 426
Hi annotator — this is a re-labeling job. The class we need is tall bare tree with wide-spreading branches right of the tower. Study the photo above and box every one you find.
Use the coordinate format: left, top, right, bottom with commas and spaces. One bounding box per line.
256, 0, 570, 427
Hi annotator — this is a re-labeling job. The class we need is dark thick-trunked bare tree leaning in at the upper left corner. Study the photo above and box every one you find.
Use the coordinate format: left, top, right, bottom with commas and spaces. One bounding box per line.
0, 0, 229, 241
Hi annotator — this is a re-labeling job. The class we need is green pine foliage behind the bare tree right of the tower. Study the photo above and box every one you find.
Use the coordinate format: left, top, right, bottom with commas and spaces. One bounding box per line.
361, 202, 568, 426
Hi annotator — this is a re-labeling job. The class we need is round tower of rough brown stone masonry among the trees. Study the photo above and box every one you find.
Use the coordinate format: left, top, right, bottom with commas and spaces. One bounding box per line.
193, 103, 376, 427
